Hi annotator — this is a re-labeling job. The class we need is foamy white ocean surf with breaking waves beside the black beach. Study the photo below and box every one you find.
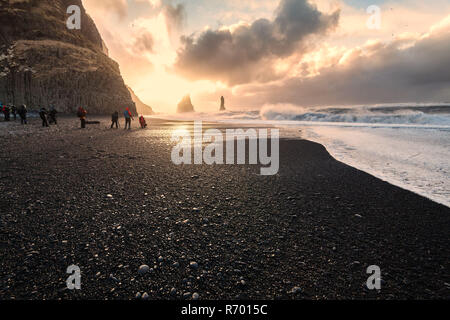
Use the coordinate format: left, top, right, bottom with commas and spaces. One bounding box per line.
150, 103, 450, 207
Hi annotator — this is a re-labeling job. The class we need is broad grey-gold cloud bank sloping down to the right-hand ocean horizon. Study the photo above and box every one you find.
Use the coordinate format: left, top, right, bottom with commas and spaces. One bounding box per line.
234, 15, 450, 106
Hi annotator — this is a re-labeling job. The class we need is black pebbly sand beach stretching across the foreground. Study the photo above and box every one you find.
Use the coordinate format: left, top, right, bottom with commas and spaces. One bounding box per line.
0, 119, 450, 299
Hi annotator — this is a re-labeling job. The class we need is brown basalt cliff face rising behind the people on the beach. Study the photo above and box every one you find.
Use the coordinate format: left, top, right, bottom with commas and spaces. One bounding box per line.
0, 0, 136, 114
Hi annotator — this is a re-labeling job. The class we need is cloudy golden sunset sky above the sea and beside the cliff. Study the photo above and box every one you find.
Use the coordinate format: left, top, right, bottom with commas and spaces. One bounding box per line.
83, 0, 450, 113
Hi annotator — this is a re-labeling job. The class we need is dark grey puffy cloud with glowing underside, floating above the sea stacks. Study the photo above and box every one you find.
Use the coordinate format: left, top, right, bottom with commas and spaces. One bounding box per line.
174, 0, 339, 85
